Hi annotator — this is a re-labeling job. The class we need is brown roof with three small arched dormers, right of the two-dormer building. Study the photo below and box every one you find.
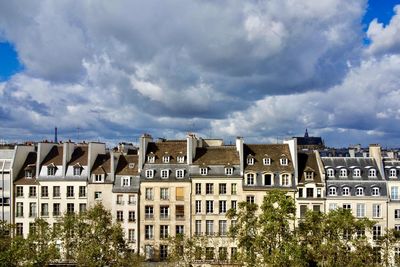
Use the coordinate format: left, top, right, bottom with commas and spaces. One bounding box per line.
243, 144, 294, 172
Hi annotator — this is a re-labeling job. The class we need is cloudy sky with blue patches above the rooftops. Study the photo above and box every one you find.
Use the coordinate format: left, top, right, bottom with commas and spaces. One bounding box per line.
0, 0, 400, 147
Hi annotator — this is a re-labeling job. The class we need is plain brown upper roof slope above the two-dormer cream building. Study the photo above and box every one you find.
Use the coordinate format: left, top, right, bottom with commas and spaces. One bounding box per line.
193, 146, 240, 165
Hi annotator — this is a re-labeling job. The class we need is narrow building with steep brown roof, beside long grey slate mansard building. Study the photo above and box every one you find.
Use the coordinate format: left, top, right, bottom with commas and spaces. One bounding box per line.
296, 151, 325, 219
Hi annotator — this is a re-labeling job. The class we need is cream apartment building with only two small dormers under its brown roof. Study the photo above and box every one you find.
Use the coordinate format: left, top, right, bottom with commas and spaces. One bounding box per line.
188, 136, 243, 263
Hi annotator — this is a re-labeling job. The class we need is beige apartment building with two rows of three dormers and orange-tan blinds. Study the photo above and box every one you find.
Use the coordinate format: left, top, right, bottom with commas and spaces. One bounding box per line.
139, 135, 191, 261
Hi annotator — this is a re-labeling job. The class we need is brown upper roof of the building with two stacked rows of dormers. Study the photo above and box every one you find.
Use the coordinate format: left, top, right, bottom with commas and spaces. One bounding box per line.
146, 140, 187, 164
